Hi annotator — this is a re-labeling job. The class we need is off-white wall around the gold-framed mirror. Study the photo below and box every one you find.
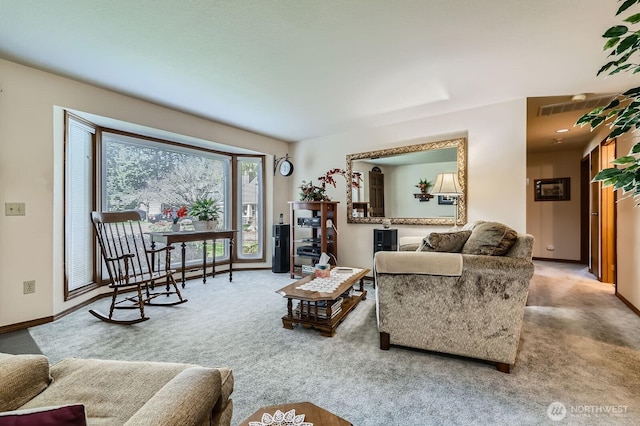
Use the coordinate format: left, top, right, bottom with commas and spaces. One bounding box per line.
291, 99, 526, 268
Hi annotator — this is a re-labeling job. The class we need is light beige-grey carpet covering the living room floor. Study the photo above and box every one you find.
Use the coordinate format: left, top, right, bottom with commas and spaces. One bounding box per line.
30, 262, 640, 426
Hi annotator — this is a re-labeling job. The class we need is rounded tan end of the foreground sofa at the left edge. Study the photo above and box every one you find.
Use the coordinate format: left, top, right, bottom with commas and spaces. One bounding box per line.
0, 354, 51, 411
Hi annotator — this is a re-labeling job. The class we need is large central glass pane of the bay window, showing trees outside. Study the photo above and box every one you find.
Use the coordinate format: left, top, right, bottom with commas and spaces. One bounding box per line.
102, 132, 232, 266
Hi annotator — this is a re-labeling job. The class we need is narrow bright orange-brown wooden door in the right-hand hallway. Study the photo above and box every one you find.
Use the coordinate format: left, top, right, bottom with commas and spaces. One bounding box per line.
600, 140, 616, 284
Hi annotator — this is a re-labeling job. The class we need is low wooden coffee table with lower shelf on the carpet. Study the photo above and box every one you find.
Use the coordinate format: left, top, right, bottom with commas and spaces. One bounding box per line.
277, 268, 369, 337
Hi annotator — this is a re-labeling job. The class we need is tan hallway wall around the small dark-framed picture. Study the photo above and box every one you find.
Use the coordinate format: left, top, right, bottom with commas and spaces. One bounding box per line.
527, 150, 582, 261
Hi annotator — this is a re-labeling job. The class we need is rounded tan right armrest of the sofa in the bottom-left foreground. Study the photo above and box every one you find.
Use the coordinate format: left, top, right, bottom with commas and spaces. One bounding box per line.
125, 367, 222, 426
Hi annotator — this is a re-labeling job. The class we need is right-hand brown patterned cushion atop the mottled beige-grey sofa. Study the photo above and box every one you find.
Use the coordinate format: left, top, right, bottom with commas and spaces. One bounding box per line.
462, 222, 518, 256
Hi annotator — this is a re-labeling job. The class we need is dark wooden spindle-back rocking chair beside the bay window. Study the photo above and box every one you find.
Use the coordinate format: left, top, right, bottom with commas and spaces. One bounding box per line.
89, 211, 187, 324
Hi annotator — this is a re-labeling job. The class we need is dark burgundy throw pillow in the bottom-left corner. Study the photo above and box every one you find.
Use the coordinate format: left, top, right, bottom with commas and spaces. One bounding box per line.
0, 404, 87, 426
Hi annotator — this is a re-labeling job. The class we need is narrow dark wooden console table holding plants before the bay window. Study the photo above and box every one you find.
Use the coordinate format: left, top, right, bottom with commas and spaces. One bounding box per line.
149, 229, 238, 288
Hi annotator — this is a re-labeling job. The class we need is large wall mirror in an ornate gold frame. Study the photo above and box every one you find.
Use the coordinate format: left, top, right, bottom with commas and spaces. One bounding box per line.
346, 138, 467, 225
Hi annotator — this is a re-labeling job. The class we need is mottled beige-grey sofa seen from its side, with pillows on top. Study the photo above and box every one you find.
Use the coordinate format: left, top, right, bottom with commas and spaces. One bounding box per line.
374, 222, 534, 373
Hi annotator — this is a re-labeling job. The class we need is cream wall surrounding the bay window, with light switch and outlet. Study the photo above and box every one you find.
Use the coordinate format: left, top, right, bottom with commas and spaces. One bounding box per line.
0, 60, 291, 327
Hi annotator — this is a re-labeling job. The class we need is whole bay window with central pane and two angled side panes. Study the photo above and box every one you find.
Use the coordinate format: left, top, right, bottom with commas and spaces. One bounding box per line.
65, 115, 264, 298
